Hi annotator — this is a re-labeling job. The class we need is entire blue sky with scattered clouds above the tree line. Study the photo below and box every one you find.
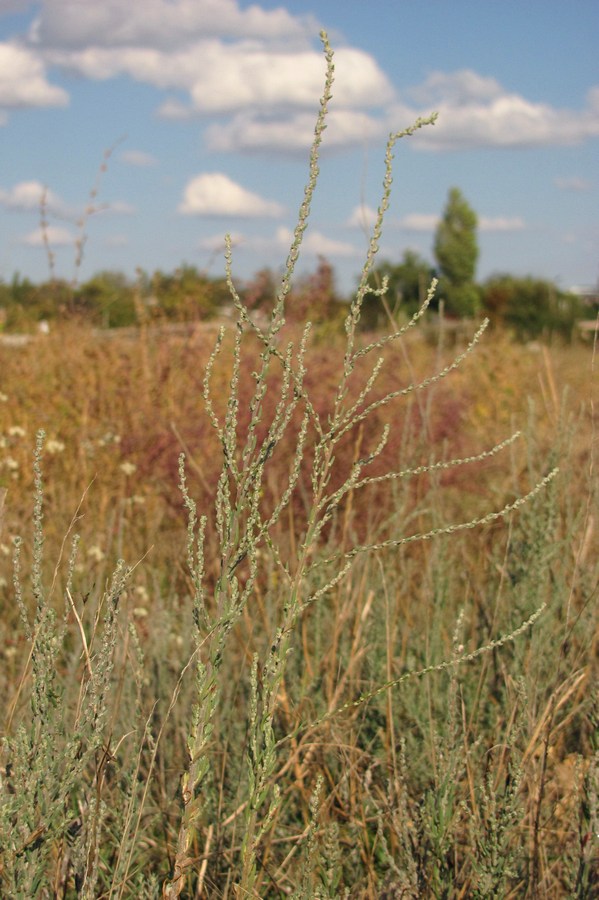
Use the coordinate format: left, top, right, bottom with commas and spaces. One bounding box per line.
0, 0, 599, 291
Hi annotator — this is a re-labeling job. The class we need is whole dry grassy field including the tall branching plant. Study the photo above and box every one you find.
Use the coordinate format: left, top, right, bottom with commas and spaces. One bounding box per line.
0, 31, 599, 900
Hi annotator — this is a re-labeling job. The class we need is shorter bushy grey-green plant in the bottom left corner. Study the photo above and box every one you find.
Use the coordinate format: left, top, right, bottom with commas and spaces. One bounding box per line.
0, 432, 134, 897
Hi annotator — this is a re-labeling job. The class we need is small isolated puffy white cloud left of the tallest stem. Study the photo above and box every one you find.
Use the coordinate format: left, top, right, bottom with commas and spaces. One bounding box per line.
179, 172, 284, 217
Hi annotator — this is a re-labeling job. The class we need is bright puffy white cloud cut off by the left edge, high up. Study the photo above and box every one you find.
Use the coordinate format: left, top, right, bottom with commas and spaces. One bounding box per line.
0, 43, 69, 109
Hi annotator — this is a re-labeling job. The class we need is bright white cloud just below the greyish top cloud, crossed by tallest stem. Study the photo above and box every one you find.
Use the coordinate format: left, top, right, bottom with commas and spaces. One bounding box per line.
39, 38, 394, 118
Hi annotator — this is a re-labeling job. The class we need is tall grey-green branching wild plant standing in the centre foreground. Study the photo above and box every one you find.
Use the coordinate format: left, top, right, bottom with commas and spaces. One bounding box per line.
165, 34, 557, 897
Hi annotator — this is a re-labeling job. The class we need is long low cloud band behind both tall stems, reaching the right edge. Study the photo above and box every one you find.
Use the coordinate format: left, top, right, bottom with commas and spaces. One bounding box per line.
204, 71, 599, 152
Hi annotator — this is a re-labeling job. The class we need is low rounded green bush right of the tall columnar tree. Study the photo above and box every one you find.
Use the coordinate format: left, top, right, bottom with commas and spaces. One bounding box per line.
481, 275, 584, 340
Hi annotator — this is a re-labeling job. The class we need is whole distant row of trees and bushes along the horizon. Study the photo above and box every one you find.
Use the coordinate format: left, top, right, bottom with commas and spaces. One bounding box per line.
0, 187, 588, 340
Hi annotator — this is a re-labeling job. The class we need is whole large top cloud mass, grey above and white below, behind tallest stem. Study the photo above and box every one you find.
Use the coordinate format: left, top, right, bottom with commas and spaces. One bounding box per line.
18, 0, 395, 151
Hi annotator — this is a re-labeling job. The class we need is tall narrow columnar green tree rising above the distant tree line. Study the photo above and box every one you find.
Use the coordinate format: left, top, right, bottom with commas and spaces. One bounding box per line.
434, 188, 480, 316
